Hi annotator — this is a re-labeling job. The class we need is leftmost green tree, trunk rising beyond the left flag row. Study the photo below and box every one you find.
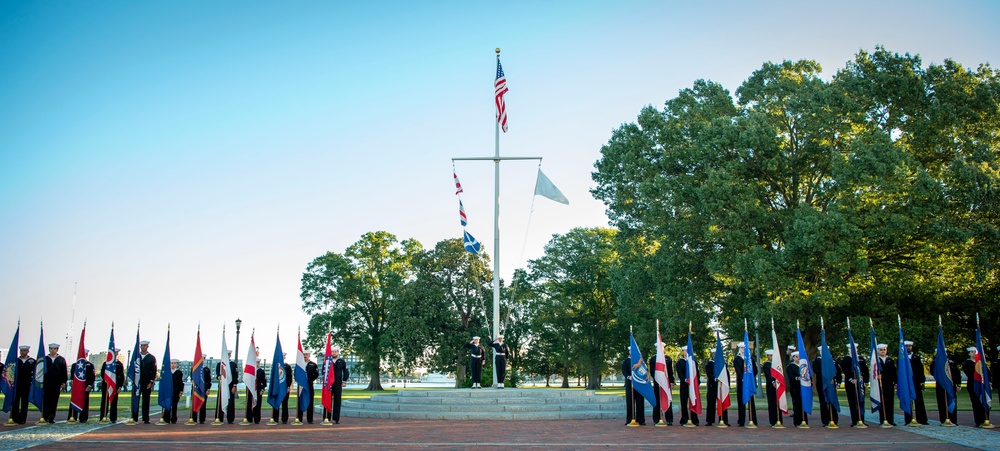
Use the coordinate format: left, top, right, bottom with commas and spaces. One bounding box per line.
302, 231, 421, 390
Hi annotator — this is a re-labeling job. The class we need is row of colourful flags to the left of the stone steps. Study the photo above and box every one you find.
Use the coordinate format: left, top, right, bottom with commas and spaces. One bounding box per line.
0, 321, 337, 413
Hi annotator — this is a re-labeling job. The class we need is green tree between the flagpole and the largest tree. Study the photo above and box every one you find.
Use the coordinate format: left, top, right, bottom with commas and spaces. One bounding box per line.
528, 228, 621, 389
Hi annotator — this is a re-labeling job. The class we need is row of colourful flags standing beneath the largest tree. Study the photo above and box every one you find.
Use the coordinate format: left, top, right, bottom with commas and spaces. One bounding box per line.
629, 315, 992, 424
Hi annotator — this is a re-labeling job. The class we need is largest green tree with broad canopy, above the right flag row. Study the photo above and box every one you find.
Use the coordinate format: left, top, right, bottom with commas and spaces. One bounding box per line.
592, 47, 1000, 356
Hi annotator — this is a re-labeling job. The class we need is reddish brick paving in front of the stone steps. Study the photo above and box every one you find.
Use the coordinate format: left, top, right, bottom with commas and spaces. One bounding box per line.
7, 418, 969, 451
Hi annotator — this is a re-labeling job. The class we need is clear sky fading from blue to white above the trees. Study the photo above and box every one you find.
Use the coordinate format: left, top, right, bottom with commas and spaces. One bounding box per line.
0, 0, 1000, 360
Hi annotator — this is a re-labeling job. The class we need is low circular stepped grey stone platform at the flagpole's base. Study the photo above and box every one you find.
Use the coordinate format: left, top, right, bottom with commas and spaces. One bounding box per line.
341, 388, 625, 420
